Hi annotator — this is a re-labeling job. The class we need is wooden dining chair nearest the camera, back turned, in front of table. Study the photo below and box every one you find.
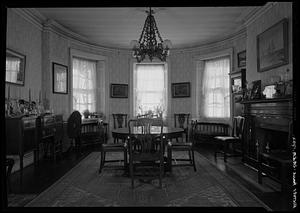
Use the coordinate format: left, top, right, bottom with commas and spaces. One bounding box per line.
128, 118, 164, 188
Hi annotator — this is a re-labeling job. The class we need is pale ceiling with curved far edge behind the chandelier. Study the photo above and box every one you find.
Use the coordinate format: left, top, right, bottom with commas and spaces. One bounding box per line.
35, 6, 259, 48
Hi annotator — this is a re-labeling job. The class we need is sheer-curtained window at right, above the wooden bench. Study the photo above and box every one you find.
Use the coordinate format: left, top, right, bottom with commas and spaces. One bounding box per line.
202, 57, 230, 119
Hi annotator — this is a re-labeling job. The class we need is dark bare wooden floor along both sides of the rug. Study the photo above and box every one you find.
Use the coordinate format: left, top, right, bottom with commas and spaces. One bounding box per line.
5, 141, 291, 211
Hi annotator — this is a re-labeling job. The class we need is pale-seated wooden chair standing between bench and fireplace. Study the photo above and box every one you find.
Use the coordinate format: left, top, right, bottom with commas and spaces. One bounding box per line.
214, 116, 245, 162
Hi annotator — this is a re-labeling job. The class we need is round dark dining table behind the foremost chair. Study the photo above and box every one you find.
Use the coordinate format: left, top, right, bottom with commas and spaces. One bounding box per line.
112, 126, 184, 171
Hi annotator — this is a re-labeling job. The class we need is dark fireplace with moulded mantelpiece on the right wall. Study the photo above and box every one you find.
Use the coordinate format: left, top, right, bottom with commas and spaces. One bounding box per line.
242, 99, 292, 168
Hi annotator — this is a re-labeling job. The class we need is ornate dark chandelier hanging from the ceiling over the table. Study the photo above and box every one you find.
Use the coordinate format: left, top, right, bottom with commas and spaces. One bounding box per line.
130, 7, 172, 63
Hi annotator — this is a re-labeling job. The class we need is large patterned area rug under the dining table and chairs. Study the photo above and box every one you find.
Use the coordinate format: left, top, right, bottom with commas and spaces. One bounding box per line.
26, 152, 270, 210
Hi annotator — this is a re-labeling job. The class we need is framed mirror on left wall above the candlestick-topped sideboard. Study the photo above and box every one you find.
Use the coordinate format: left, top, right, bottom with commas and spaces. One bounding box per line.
5, 48, 26, 86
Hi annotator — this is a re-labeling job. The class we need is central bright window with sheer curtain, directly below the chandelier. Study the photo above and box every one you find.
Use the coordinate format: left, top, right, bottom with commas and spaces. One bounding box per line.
133, 64, 167, 116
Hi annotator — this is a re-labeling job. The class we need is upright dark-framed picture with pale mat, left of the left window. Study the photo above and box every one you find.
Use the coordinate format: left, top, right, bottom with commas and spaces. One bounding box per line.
52, 62, 68, 94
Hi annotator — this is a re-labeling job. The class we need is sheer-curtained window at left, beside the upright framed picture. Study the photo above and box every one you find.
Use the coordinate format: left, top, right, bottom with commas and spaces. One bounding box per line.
73, 57, 96, 113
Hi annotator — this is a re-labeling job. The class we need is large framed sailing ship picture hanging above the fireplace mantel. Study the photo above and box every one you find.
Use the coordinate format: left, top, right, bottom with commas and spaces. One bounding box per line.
257, 18, 289, 72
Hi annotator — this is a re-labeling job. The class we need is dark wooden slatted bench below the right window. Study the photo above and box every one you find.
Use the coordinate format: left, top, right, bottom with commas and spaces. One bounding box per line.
192, 122, 229, 144
